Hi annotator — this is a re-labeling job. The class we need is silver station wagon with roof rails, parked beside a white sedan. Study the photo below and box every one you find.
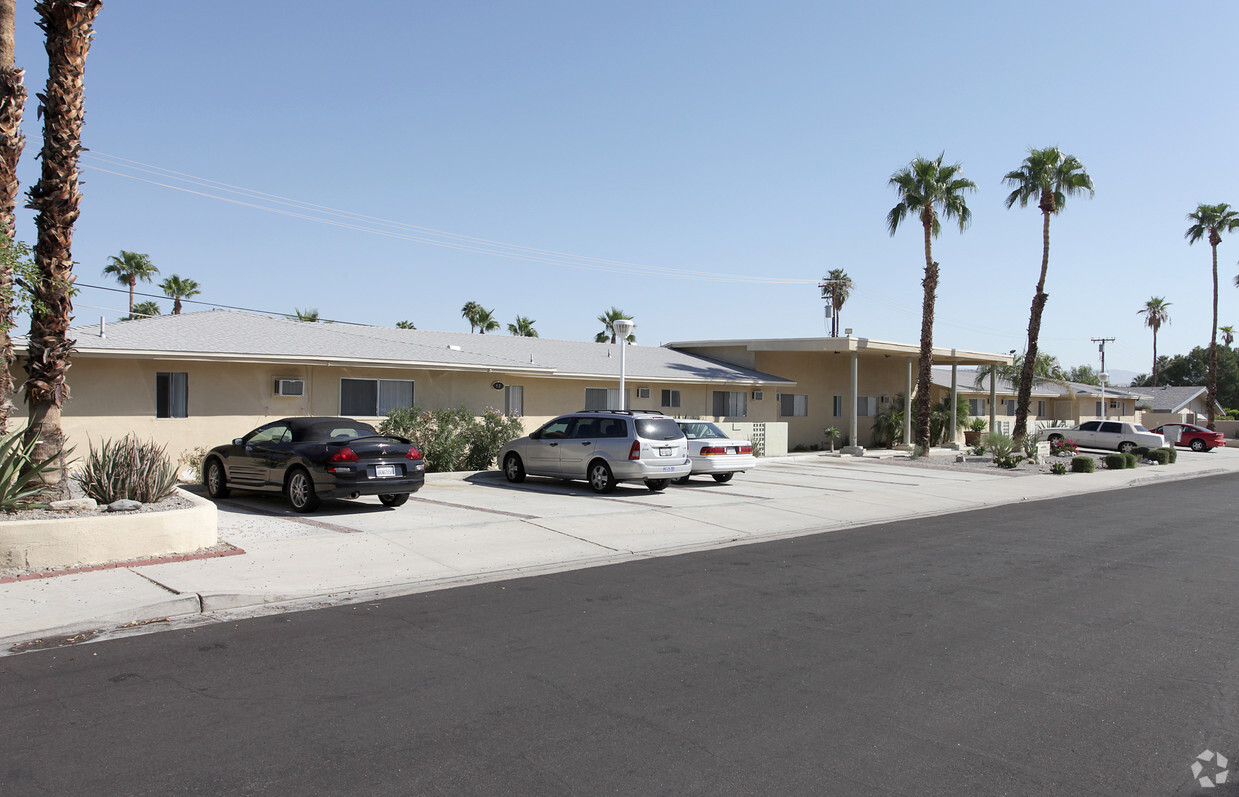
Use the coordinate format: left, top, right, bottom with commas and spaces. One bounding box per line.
499, 410, 693, 493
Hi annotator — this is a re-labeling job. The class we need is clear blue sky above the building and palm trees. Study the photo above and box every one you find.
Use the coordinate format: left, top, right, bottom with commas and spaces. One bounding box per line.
9, 0, 1239, 372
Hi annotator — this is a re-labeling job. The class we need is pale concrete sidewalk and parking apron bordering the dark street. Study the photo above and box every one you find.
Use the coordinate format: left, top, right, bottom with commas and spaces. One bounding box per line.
0, 449, 1239, 654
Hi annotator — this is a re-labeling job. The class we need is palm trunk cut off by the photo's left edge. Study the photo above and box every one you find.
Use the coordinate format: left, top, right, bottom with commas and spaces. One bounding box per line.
0, 0, 26, 434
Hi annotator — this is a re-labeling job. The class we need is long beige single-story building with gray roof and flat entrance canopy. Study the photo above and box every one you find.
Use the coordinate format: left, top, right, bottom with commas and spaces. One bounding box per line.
15, 310, 1010, 457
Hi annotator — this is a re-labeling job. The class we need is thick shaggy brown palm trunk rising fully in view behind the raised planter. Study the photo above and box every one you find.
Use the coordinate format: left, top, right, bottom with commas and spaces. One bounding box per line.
22, 0, 103, 497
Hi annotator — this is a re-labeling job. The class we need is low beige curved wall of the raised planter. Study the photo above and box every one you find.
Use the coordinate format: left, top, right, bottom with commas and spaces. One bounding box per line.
0, 490, 219, 570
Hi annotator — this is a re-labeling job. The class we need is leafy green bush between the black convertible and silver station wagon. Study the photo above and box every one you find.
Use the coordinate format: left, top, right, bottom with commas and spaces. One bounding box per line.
379, 407, 524, 473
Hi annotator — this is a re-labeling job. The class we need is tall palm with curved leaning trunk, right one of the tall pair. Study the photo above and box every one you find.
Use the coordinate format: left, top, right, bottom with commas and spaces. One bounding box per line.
1002, 146, 1093, 444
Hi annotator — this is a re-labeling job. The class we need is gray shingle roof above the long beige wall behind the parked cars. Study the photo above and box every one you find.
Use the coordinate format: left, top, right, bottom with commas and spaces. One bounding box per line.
50, 310, 794, 385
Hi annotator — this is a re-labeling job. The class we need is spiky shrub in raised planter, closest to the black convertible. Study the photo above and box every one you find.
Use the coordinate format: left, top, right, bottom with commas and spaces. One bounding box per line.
73, 435, 176, 503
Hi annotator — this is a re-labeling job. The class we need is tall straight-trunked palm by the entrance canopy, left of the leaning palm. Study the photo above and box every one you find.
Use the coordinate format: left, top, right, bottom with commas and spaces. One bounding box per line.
886, 154, 976, 451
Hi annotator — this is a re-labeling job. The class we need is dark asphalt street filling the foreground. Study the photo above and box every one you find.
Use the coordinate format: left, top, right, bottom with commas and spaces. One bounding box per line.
0, 476, 1239, 796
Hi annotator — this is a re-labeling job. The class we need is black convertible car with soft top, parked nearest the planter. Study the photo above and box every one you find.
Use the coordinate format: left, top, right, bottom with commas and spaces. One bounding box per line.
202, 418, 426, 512
